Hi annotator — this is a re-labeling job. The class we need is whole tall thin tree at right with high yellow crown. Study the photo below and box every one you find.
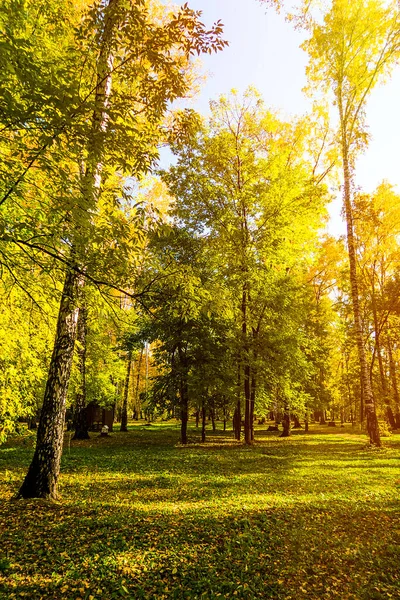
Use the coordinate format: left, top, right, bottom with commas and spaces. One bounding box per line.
302, 0, 400, 446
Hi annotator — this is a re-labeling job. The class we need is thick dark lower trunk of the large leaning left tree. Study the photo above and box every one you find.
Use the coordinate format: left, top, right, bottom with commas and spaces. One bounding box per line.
18, 271, 80, 499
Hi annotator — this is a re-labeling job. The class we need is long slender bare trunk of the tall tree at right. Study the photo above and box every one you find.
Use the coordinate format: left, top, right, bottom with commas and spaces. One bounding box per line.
338, 106, 381, 446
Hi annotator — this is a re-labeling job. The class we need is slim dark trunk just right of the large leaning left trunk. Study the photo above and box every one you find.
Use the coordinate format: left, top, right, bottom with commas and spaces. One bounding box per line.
72, 304, 90, 440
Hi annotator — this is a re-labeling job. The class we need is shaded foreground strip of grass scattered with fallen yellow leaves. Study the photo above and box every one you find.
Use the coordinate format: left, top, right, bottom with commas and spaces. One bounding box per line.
0, 501, 400, 600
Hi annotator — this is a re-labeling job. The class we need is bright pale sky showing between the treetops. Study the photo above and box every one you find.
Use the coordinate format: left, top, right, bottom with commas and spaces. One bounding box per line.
170, 0, 400, 234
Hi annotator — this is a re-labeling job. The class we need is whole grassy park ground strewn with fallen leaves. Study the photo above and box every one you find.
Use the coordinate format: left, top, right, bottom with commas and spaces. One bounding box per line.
0, 422, 400, 600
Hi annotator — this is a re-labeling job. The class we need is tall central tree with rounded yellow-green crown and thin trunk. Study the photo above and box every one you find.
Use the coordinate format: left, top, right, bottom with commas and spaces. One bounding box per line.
163, 90, 325, 444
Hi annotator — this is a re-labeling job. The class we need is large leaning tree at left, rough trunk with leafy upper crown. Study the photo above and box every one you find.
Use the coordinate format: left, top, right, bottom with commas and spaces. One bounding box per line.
14, 0, 228, 498
